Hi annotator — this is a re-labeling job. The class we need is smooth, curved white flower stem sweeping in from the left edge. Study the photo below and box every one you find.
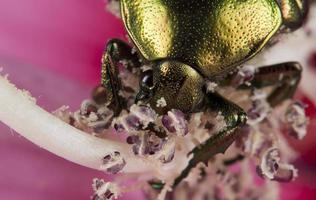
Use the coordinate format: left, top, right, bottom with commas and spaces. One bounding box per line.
0, 76, 150, 172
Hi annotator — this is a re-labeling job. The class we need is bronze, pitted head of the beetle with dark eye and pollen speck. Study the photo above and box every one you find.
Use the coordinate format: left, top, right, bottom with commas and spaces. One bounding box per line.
136, 61, 204, 114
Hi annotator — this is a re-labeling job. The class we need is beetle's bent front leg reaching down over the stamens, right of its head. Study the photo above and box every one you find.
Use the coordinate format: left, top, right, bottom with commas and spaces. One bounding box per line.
174, 93, 247, 187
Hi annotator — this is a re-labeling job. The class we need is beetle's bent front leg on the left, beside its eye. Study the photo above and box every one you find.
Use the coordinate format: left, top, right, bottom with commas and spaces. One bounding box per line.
101, 39, 140, 116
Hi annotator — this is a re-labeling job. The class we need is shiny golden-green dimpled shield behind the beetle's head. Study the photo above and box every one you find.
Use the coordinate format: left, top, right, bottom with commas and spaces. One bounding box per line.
121, 0, 282, 78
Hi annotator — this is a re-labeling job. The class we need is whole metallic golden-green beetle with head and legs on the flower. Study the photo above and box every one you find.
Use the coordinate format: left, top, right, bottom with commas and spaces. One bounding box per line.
102, 0, 308, 184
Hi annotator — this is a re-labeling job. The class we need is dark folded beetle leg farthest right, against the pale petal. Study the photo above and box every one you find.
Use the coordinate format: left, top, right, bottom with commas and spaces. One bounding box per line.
247, 62, 302, 107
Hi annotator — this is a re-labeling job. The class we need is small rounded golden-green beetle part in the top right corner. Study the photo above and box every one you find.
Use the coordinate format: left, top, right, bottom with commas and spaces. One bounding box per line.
277, 0, 310, 31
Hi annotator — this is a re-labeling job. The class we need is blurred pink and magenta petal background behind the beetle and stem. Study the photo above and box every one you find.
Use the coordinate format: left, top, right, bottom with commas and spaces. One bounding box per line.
0, 0, 316, 200
